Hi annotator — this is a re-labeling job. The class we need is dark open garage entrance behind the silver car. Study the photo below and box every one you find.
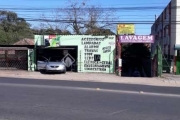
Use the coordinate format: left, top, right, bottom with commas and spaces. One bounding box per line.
36, 46, 78, 72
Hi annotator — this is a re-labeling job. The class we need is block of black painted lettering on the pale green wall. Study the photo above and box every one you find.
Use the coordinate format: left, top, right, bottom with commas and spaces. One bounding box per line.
81, 37, 115, 72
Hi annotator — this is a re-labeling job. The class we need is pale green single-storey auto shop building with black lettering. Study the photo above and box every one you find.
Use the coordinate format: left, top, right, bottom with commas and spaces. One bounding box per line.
28, 35, 116, 73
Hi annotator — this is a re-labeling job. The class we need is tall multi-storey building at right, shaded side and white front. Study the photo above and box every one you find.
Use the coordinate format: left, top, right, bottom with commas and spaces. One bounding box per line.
151, 0, 176, 72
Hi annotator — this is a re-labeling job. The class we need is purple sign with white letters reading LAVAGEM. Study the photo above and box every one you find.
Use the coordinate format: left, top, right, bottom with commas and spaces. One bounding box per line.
118, 35, 154, 43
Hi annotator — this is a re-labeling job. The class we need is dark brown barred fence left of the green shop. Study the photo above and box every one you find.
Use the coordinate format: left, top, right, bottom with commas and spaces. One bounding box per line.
0, 49, 28, 70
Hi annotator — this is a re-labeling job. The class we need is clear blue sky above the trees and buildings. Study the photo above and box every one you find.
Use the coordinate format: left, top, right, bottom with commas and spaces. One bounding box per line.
0, 0, 170, 35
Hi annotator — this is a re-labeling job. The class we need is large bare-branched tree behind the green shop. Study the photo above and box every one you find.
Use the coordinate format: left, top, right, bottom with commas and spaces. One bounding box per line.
43, 0, 116, 35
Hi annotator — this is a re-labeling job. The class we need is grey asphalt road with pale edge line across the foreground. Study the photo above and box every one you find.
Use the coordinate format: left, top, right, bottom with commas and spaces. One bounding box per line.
0, 78, 180, 120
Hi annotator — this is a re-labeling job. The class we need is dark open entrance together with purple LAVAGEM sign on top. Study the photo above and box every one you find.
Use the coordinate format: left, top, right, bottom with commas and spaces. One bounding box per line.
118, 35, 154, 77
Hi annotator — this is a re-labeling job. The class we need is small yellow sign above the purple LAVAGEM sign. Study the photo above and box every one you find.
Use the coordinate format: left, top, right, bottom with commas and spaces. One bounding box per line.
117, 24, 135, 35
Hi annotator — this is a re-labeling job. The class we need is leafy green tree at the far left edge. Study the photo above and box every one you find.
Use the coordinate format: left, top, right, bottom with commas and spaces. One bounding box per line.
0, 11, 33, 45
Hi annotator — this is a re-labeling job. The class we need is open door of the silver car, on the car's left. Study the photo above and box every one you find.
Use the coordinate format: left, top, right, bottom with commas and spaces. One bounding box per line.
37, 56, 48, 70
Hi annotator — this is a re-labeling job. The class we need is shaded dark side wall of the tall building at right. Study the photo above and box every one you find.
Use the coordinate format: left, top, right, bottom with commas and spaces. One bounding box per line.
151, 2, 173, 56
